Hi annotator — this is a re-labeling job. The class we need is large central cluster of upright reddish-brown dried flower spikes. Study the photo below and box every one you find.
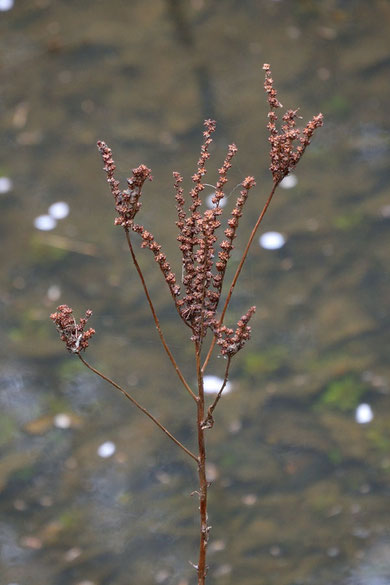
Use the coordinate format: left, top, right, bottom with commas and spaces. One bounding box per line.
174, 120, 256, 342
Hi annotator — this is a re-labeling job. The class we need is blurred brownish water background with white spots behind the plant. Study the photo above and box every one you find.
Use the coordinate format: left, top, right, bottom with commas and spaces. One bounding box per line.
0, 0, 390, 585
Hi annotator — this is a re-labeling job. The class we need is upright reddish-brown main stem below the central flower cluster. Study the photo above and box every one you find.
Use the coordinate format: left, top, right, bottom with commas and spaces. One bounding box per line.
195, 342, 209, 585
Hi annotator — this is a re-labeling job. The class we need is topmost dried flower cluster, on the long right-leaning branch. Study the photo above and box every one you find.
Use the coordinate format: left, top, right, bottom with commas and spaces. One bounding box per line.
263, 63, 323, 183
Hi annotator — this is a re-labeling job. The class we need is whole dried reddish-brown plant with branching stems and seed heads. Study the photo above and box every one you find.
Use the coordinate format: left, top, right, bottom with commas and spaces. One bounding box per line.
51, 64, 323, 585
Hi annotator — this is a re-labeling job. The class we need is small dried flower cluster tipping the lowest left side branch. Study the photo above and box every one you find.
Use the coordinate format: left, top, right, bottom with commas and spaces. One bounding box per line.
50, 305, 95, 353
